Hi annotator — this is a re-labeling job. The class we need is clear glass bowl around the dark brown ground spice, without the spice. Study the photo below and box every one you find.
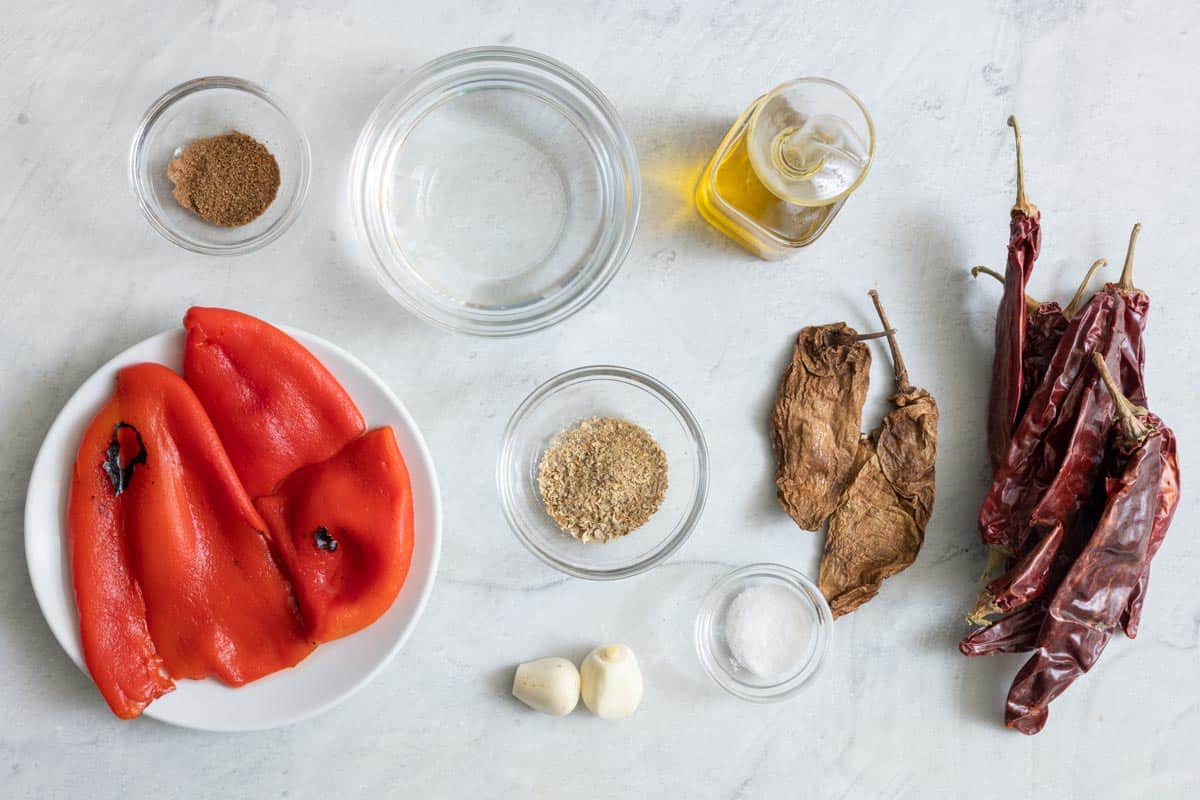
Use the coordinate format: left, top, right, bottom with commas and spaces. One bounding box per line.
130, 77, 310, 255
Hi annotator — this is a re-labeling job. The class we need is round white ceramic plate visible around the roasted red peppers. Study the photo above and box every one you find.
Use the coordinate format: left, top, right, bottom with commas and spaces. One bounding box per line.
25, 329, 442, 730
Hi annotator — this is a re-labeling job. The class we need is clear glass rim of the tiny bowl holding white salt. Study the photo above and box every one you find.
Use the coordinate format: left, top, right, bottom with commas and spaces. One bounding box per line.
692, 561, 833, 703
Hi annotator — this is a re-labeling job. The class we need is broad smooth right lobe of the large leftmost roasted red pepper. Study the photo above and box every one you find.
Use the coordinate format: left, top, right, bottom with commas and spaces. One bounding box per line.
109, 363, 313, 686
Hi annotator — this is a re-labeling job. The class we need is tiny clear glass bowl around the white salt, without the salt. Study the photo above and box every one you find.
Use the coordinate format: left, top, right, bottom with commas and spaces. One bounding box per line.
695, 564, 833, 703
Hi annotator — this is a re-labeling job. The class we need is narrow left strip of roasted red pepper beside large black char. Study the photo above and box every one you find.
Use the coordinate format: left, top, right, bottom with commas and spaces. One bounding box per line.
67, 397, 175, 720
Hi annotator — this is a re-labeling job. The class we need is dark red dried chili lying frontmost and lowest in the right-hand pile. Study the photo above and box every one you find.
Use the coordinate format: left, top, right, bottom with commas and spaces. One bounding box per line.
1004, 354, 1180, 734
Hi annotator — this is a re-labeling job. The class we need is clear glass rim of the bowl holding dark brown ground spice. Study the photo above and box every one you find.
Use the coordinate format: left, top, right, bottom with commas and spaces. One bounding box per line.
130, 76, 312, 255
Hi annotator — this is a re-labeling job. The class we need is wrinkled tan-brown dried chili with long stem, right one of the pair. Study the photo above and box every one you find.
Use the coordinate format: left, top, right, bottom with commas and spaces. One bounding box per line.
817, 290, 937, 616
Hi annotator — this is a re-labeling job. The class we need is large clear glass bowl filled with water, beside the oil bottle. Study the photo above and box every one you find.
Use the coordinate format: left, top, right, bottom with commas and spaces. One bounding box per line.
350, 47, 641, 336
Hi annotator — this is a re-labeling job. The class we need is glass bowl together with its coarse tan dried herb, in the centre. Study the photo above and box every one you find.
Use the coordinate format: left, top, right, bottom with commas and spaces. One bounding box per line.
497, 366, 708, 581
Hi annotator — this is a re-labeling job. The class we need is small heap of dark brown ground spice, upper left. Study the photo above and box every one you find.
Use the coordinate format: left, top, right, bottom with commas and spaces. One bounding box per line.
167, 131, 280, 228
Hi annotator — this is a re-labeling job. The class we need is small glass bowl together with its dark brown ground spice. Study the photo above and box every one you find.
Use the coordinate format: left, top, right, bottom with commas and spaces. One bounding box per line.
130, 77, 310, 255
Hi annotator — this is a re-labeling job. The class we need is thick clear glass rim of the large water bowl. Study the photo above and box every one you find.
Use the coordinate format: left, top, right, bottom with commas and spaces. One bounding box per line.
349, 47, 642, 337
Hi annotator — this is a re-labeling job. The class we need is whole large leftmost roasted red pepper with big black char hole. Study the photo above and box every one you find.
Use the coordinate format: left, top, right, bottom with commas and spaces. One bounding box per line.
68, 363, 313, 717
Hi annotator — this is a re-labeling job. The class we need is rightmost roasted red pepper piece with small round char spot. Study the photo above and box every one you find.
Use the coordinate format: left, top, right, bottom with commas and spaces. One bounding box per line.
254, 428, 413, 642
